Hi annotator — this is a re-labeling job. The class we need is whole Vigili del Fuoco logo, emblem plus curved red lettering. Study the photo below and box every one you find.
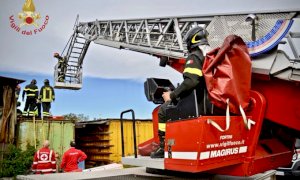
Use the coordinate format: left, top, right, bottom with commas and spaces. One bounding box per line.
9, 0, 49, 36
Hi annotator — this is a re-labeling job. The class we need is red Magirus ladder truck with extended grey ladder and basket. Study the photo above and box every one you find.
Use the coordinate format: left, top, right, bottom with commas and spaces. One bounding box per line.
55, 9, 300, 176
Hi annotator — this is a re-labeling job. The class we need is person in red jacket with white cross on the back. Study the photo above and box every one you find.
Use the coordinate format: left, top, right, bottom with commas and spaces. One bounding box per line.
32, 140, 56, 174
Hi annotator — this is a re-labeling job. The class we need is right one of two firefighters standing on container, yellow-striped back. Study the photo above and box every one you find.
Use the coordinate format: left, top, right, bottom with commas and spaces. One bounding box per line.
39, 79, 55, 118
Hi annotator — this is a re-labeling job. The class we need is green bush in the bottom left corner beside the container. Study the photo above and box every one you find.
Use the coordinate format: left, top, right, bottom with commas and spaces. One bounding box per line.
0, 145, 35, 177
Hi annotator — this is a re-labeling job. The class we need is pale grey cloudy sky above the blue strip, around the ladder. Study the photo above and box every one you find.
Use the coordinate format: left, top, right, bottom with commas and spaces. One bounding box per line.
0, 0, 300, 119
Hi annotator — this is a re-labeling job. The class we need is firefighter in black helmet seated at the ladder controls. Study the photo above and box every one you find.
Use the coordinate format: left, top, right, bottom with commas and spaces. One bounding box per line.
151, 27, 210, 158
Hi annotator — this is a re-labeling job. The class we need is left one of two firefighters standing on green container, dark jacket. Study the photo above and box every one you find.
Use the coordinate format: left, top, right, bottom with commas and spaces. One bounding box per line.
22, 79, 39, 116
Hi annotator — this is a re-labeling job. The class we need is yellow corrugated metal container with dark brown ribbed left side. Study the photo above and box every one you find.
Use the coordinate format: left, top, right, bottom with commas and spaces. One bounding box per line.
76, 119, 153, 167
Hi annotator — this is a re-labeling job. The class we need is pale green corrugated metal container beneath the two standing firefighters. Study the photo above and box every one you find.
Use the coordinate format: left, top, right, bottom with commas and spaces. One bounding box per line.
17, 120, 75, 157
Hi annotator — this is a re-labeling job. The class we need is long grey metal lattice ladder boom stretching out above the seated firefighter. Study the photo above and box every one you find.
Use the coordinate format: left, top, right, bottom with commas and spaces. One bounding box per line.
55, 10, 300, 89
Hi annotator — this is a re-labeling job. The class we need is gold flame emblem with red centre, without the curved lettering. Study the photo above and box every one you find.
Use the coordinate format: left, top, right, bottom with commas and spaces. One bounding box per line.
19, 0, 41, 27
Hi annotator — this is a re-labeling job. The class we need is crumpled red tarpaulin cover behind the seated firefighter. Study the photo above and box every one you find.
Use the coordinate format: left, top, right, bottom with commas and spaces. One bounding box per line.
202, 35, 251, 114
